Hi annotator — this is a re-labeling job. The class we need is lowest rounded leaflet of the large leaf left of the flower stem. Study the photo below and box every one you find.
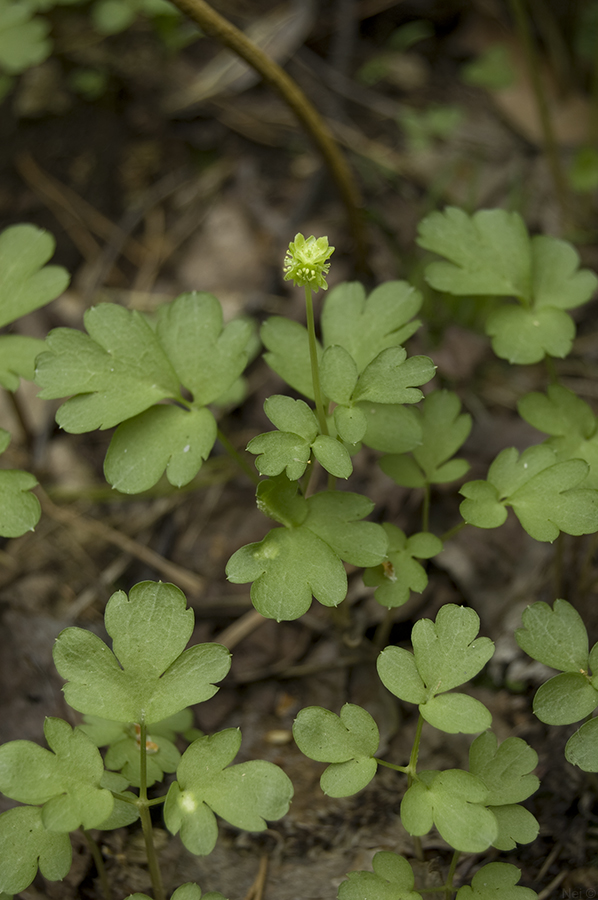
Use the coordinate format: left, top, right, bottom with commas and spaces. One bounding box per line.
104, 406, 217, 494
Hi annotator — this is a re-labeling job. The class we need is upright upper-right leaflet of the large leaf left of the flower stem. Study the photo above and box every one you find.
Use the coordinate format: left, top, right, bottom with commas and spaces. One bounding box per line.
157, 291, 253, 406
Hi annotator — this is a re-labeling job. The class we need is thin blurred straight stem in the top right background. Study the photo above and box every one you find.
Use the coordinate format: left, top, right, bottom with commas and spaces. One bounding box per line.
509, 0, 569, 222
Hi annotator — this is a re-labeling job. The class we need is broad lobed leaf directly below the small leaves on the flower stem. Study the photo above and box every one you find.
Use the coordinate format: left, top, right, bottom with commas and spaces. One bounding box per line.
226, 475, 387, 622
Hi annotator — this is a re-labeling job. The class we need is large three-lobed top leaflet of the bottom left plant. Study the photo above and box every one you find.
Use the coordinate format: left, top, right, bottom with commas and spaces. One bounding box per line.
54, 581, 230, 725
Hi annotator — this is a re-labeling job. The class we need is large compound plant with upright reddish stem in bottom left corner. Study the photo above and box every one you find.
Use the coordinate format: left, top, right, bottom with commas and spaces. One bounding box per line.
0, 582, 293, 900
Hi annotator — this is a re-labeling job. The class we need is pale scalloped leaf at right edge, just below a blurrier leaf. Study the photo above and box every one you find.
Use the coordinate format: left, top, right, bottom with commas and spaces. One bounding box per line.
460, 444, 598, 541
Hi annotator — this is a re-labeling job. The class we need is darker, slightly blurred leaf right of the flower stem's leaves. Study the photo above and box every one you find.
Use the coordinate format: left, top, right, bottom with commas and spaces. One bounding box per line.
380, 391, 471, 486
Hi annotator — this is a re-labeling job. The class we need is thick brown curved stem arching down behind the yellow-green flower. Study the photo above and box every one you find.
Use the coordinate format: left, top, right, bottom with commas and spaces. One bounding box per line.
166, 0, 367, 271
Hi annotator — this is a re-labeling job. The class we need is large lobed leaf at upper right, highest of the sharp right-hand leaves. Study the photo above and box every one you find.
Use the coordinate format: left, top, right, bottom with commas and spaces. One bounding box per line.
418, 207, 598, 364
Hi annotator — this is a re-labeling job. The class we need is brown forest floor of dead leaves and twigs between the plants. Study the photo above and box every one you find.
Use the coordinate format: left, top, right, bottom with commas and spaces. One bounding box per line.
0, 0, 598, 900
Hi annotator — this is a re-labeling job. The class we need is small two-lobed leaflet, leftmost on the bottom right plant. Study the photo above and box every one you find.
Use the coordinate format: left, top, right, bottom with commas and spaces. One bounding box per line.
293, 703, 380, 797
